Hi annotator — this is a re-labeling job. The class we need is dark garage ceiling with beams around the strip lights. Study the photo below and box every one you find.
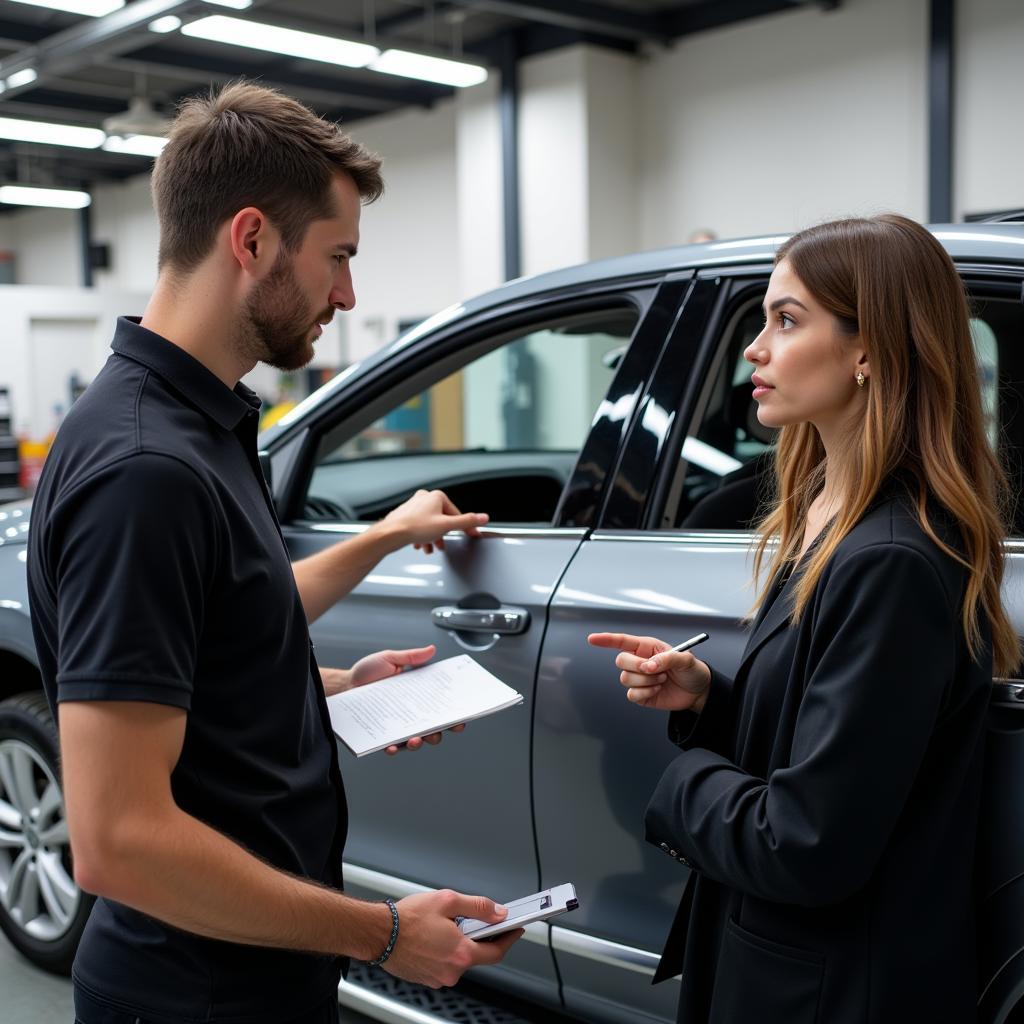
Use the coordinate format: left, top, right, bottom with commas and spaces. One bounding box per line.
0, 0, 839, 195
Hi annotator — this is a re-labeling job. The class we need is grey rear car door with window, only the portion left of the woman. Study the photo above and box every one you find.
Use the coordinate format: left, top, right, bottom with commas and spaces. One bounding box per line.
534, 268, 771, 1022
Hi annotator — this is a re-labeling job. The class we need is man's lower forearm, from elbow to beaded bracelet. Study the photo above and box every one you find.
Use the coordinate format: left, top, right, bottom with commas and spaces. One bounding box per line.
80, 808, 391, 959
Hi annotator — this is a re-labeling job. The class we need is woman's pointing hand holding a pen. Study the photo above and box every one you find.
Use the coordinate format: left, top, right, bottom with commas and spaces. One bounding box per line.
587, 633, 711, 712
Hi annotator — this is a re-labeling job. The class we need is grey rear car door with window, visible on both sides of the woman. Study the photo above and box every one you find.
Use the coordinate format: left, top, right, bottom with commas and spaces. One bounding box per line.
534, 258, 1024, 1022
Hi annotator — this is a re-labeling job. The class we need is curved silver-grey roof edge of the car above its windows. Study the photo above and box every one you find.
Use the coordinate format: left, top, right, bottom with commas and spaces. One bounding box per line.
260, 223, 1024, 445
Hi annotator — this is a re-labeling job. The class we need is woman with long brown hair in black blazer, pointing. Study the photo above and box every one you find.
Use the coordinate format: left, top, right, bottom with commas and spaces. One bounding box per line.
590, 216, 1018, 1024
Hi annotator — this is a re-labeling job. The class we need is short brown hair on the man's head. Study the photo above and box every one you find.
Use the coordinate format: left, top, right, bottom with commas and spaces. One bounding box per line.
152, 82, 384, 272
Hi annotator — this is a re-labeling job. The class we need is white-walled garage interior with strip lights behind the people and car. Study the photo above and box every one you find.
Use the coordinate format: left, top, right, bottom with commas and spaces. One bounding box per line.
0, 0, 1024, 1024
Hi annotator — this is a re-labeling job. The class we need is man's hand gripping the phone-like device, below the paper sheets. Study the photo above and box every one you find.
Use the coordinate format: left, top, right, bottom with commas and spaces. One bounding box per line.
384, 889, 523, 988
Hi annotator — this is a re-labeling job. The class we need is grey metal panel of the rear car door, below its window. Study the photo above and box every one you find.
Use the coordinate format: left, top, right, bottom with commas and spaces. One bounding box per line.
534, 530, 752, 1024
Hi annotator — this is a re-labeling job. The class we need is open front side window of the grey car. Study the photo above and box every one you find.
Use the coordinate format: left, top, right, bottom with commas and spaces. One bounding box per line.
304, 306, 638, 524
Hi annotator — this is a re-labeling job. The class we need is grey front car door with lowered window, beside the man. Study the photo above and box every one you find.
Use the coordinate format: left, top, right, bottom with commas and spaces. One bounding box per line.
284, 284, 664, 1002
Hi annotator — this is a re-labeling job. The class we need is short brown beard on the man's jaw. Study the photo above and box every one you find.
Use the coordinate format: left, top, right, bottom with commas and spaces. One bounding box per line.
239, 250, 334, 370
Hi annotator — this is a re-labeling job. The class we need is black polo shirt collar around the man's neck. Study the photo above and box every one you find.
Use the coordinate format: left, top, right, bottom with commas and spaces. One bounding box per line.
111, 316, 260, 430
